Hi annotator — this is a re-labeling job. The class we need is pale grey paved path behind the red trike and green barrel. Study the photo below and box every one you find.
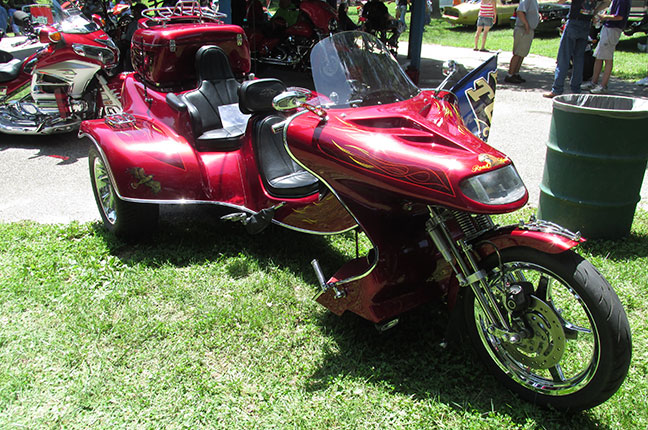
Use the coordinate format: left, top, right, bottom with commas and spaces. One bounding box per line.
0, 41, 648, 223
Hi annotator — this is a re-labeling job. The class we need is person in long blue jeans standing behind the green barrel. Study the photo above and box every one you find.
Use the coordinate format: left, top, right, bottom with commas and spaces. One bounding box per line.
543, 0, 610, 98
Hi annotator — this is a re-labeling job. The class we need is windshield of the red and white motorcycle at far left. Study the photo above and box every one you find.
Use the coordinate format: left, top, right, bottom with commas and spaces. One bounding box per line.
23, 0, 99, 34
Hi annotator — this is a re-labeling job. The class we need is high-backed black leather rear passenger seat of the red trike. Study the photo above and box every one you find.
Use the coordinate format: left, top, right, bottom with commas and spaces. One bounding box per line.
167, 45, 245, 151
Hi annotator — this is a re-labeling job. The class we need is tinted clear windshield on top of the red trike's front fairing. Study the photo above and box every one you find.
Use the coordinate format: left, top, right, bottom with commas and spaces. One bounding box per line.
311, 31, 420, 108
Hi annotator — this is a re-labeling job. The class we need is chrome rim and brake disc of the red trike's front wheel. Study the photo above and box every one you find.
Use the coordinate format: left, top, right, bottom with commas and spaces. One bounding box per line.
474, 262, 600, 396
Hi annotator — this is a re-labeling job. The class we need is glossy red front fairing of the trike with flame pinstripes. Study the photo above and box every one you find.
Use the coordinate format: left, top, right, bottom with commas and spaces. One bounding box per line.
288, 92, 528, 214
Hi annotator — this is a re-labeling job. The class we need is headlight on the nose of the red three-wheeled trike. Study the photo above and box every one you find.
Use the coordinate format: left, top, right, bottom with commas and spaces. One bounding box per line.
459, 164, 526, 205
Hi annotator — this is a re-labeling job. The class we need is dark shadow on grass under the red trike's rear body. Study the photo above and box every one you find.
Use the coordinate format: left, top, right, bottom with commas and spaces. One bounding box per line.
94, 205, 352, 288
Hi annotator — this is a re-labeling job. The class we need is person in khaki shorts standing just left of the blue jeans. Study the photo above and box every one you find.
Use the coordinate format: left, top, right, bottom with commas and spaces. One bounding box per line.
504, 0, 540, 84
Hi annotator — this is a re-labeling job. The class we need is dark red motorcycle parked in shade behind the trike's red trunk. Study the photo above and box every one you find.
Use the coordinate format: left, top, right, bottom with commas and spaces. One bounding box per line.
244, 0, 338, 69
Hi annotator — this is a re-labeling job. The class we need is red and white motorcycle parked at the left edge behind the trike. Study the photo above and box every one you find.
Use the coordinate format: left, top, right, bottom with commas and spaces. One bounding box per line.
0, 0, 121, 134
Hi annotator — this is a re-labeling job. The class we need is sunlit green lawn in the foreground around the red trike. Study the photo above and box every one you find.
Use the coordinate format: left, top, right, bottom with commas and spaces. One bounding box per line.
0, 212, 648, 429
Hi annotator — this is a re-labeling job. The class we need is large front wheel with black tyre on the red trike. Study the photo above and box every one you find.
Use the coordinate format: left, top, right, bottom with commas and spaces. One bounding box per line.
464, 248, 632, 410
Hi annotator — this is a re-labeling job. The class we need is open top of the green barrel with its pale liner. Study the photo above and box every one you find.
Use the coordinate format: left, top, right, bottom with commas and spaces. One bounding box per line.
553, 94, 648, 119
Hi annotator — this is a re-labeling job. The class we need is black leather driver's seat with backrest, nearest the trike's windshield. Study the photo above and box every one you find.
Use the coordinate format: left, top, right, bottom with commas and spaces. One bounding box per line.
239, 79, 319, 198
